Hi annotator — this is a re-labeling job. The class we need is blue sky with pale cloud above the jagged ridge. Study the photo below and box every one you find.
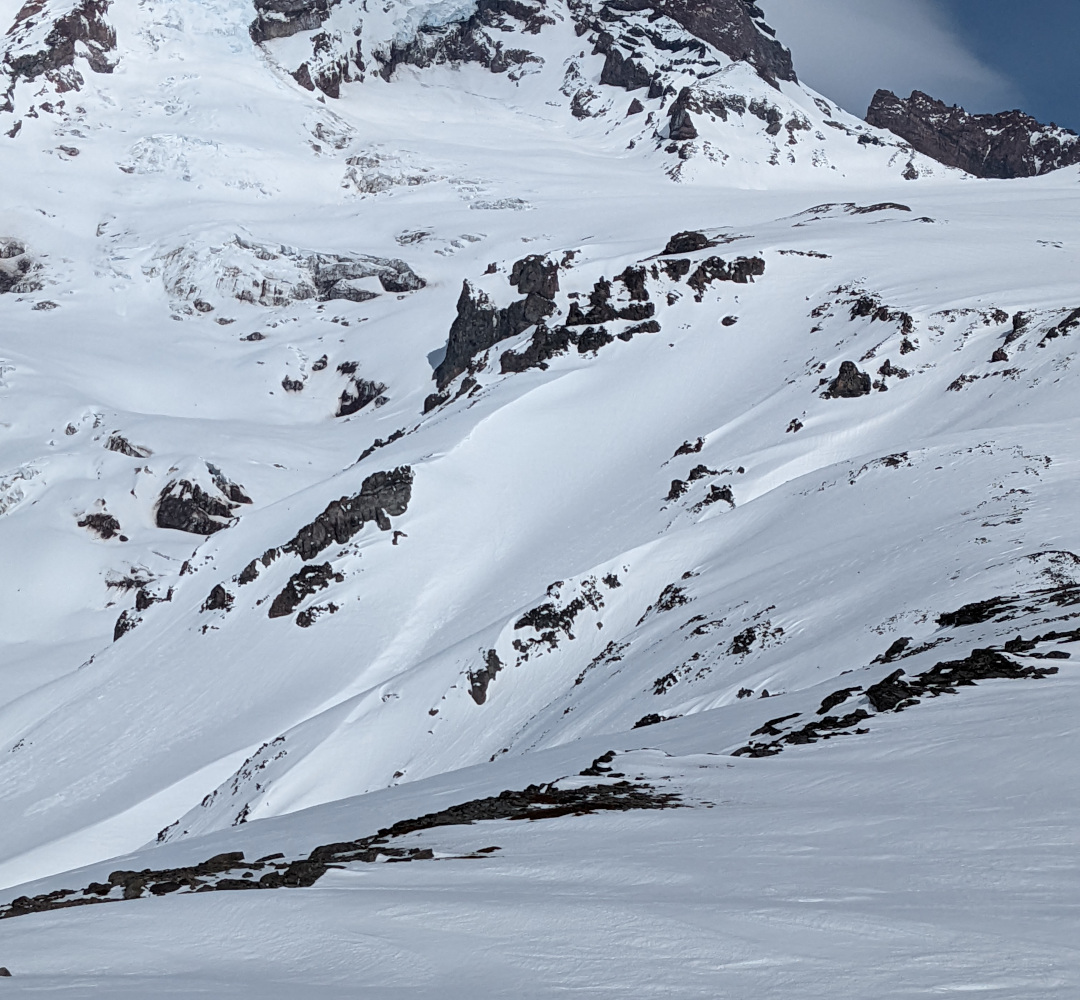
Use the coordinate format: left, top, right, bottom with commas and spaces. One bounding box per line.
758, 0, 1080, 132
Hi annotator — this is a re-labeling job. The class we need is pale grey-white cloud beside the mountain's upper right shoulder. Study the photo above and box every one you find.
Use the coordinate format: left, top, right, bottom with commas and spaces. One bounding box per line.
758, 0, 1021, 116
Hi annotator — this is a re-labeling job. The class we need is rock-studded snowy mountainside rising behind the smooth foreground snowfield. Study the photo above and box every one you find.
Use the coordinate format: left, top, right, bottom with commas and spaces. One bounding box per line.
0, 0, 1080, 996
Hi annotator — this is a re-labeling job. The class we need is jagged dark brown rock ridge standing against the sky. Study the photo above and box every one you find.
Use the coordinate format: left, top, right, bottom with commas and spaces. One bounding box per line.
866, 91, 1080, 179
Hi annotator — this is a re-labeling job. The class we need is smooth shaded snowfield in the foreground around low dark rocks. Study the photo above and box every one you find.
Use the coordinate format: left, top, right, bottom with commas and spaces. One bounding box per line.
0, 673, 1080, 1000
